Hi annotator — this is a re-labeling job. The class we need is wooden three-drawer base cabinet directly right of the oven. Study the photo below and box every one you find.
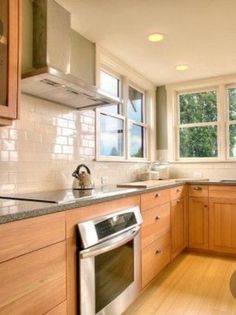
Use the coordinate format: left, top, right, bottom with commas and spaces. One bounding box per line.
141, 189, 170, 288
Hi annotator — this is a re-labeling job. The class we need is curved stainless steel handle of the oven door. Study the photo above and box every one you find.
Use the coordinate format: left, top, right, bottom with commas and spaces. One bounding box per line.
80, 226, 140, 259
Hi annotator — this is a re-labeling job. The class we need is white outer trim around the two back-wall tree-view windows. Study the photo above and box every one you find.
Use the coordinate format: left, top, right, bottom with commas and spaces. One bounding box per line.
166, 74, 236, 164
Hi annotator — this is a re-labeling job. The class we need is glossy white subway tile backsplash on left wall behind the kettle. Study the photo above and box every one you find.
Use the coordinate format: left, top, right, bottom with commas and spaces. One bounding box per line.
0, 95, 146, 194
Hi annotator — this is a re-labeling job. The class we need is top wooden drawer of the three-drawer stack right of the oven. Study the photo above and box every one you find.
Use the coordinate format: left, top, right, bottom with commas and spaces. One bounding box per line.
141, 189, 170, 211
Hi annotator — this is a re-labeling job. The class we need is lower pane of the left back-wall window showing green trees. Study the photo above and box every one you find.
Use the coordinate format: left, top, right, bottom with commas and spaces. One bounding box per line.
180, 126, 218, 157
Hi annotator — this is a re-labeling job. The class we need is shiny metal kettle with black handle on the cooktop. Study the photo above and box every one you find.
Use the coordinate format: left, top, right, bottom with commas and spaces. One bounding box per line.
72, 164, 93, 190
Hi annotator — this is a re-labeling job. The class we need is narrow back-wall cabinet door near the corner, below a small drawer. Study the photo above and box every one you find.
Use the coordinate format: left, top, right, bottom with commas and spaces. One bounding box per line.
188, 197, 208, 249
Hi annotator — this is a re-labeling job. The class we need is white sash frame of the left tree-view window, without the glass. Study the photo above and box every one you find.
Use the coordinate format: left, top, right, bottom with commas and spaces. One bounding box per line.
175, 86, 221, 161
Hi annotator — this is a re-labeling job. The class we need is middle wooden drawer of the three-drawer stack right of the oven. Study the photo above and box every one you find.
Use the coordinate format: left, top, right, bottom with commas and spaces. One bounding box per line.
141, 203, 170, 247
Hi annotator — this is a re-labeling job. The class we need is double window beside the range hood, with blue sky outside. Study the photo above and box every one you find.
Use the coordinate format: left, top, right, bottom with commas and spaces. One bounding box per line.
97, 70, 147, 160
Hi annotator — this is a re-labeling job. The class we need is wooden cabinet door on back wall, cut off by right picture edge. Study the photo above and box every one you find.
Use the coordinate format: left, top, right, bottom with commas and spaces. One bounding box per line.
209, 198, 236, 254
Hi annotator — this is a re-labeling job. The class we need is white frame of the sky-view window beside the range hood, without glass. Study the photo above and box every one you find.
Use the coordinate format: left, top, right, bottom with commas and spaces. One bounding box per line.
96, 66, 148, 162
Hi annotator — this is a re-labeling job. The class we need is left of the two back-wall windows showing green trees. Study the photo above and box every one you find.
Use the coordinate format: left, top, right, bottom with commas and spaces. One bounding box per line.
177, 89, 218, 159
